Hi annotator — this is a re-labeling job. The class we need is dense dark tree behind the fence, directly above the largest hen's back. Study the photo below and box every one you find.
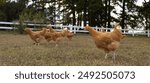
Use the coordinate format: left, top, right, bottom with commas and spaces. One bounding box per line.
88, 0, 106, 26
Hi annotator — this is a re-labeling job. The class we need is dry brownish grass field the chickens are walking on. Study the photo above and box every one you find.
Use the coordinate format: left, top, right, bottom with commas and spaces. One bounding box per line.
0, 31, 150, 66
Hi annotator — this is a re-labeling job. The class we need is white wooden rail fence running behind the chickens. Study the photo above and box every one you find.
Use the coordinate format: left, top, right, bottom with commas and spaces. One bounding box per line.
0, 22, 150, 37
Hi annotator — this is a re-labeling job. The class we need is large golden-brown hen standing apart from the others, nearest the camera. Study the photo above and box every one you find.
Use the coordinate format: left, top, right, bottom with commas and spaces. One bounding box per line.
85, 25, 124, 60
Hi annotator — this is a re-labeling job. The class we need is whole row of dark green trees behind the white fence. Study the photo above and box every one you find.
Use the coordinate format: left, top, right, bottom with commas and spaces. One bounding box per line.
0, 0, 150, 28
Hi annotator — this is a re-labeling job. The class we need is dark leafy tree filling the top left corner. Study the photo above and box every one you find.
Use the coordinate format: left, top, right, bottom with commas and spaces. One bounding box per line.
0, 0, 28, 21
